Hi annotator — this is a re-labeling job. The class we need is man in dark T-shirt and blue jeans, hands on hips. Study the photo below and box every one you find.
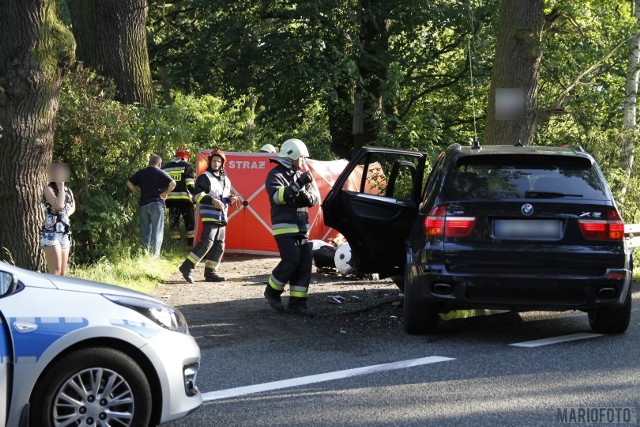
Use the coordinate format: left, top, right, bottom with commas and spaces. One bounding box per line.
127, 154, 176, 257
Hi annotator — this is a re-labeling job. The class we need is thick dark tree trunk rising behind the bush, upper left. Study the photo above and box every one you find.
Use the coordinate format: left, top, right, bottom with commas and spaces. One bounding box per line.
67, 0, 153, 105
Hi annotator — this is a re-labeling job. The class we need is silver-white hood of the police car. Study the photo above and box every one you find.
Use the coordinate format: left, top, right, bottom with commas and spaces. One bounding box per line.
0, 261, 156, 300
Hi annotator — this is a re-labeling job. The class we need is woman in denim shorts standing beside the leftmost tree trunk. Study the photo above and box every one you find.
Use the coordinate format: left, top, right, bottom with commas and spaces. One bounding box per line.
40, 163, 76, 276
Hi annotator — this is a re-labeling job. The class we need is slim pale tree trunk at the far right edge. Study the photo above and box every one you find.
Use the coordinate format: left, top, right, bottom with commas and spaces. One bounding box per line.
620, 0, 640, 202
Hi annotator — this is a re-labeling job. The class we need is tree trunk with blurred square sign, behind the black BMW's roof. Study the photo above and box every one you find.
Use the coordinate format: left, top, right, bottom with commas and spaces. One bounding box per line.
483, 0, 544, 145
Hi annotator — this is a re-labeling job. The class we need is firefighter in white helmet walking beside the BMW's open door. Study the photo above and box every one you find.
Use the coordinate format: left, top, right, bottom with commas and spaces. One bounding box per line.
264, 139, 320, 317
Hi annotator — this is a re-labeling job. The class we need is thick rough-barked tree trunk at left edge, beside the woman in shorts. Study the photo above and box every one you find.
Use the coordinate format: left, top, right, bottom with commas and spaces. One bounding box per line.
0, 0, 75, 270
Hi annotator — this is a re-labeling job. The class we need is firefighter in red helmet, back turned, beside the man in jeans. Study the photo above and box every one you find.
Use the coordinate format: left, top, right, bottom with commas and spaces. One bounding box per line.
162, 146, 196, 249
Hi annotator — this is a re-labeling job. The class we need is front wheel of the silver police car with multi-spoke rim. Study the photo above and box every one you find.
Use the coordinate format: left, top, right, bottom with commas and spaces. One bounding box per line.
30, 348, 152, 427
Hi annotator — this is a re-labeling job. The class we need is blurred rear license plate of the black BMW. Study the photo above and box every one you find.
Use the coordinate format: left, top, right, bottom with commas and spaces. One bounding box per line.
493, 219, 562, 240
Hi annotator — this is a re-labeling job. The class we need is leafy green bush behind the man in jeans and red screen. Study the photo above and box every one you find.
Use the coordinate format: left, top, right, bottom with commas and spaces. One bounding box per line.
54, 68, 256, 263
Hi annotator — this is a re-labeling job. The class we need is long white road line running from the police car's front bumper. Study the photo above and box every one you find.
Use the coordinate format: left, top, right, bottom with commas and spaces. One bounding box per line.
202, 356, 455, 402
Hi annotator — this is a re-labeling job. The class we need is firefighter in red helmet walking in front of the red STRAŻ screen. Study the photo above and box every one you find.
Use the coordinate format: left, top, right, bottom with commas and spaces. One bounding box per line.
179, 149, 236, 283
